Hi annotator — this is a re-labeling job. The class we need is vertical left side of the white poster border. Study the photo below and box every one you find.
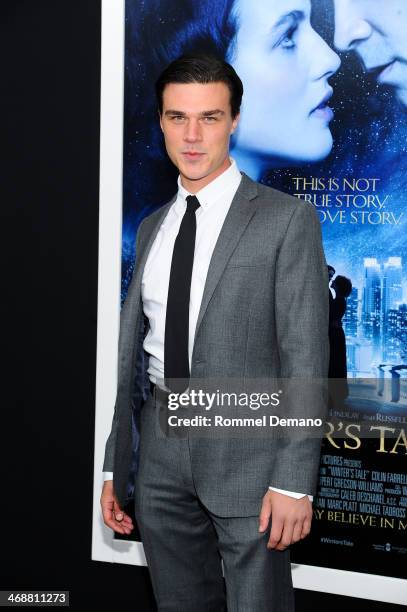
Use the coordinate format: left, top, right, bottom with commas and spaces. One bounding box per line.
92, 0, 125, 561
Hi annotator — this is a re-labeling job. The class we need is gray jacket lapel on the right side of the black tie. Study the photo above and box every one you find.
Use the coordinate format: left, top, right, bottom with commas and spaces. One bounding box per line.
194, 173, 257, 344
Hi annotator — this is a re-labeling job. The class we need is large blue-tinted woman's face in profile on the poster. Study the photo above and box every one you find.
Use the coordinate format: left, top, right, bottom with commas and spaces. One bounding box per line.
230, 0, 340, 163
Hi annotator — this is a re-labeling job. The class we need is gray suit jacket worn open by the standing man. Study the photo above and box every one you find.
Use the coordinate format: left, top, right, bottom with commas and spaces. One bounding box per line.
103, 174, 329, 516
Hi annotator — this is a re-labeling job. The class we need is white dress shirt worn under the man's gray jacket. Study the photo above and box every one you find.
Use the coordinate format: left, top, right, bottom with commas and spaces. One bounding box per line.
104, 159, 313, 501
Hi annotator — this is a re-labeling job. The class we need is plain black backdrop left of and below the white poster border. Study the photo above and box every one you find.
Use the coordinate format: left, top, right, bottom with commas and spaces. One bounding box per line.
0, 0, 401, 612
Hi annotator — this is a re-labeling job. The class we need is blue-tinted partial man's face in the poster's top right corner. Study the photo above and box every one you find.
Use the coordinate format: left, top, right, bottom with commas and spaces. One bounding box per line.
334, 0, 407, 106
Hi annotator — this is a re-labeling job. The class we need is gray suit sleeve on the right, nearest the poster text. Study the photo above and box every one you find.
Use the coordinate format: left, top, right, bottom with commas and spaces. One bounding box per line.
269, 202, 329, 495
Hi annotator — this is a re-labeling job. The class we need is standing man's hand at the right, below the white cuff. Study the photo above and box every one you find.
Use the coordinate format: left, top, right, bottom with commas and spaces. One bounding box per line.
259, 490, 312, 550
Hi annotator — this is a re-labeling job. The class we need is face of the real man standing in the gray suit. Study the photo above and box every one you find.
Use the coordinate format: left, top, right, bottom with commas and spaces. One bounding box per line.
160, 83, 238, 193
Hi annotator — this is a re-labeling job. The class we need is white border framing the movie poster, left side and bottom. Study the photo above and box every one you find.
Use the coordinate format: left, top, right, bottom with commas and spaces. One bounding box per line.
92, 0, 407, 604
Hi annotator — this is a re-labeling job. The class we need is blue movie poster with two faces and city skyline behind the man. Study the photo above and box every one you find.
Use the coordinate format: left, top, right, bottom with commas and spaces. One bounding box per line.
122, 0, 407, 577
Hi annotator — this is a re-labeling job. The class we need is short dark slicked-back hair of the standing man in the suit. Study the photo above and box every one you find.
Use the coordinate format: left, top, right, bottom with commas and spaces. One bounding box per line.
155, 54, 243, 119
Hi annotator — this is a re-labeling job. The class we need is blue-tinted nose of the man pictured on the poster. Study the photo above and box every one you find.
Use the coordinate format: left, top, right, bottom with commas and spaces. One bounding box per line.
334, 0, 372, 51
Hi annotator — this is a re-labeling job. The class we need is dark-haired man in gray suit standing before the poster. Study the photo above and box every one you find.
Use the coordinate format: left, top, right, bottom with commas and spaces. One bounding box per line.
101, 56, 329, 612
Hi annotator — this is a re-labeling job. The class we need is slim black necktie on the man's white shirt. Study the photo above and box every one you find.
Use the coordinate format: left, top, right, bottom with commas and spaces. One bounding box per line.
164, 196, 200, 393
